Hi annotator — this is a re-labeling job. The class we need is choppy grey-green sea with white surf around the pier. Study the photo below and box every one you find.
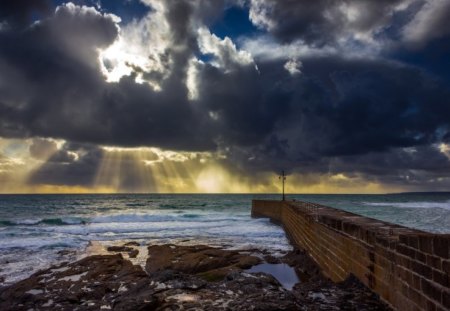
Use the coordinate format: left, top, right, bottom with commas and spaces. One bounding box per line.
0, 193, 450, 286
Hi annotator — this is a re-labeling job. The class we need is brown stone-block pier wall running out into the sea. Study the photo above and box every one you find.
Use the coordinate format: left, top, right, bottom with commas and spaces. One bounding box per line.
252, 200, 450, 311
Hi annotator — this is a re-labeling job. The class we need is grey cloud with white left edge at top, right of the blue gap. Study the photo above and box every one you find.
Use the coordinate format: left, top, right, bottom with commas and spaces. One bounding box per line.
250, 0, 414, 45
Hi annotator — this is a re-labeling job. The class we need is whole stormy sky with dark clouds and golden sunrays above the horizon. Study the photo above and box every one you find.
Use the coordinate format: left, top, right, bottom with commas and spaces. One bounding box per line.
0, 0, 450, 193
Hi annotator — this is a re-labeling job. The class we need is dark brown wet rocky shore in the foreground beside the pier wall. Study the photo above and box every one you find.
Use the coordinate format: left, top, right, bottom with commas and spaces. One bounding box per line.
0, 242, 389, 311
